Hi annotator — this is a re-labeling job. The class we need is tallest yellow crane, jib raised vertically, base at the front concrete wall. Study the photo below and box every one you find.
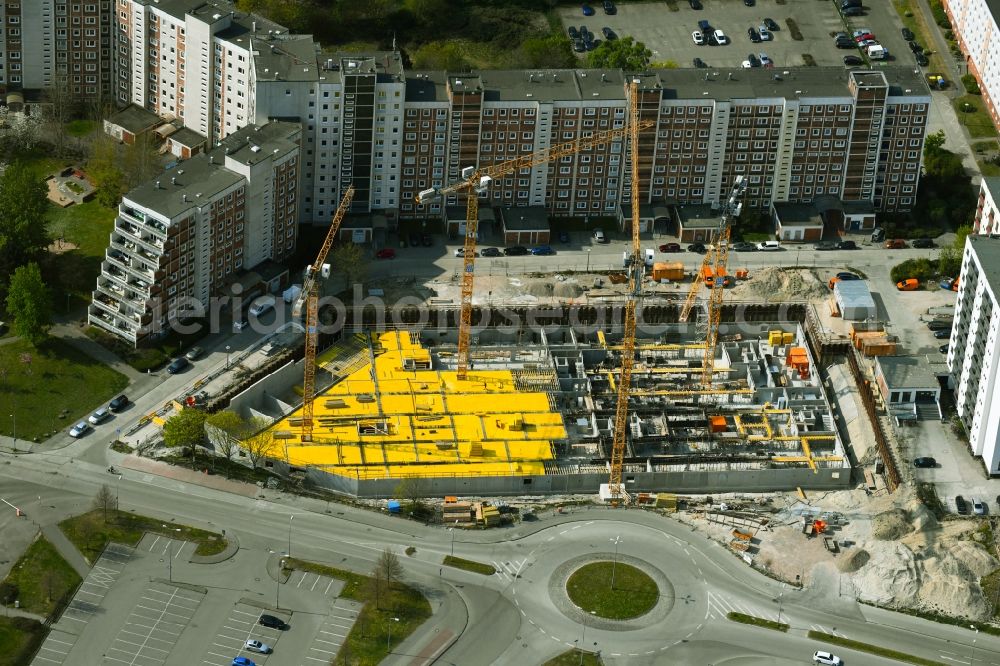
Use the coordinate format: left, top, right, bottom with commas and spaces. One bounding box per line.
608, 79, 645, 506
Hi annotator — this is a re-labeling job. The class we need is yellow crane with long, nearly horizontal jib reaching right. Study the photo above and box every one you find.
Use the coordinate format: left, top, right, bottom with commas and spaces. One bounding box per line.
416, 108, 654, 379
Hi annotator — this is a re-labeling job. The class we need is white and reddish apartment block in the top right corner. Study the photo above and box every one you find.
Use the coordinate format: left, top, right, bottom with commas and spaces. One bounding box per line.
942, 0, 1000, 132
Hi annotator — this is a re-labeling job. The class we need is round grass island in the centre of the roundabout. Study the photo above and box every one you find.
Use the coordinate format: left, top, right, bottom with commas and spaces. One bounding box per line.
566, 562, 660, 620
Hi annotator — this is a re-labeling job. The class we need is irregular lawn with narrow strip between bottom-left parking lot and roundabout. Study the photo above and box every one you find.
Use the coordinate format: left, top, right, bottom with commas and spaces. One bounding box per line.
285, 557, 431, 664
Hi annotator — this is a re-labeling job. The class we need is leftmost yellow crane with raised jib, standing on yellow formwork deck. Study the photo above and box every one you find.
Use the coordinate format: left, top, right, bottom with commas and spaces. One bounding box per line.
292, 185, 354, 442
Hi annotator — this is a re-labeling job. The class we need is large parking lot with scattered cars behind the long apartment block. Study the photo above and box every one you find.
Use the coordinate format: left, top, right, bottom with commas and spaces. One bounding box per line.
560, 0, 926, 68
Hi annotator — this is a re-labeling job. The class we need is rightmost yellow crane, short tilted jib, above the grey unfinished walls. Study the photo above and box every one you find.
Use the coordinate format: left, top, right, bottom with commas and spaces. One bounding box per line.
679, 176, 747, 386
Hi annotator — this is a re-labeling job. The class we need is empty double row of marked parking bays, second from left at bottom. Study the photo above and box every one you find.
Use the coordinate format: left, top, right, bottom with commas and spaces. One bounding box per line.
104, 583, 205, 666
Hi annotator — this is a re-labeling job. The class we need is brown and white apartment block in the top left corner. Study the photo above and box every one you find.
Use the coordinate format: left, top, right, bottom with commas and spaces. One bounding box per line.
0, 0, 112, 102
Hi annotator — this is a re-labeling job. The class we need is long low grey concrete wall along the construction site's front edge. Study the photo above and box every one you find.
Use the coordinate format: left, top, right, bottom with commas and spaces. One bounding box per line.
308, 467, 851, 497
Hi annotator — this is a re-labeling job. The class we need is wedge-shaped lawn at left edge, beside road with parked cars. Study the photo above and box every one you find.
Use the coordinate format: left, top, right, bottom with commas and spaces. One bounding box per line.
0, 338, 128, 442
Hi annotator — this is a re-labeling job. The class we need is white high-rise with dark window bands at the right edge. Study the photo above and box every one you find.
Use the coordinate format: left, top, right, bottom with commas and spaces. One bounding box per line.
948, 234, 1000, 475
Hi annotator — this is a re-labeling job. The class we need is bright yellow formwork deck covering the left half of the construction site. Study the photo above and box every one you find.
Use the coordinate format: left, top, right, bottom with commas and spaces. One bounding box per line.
269, 332, 566, 479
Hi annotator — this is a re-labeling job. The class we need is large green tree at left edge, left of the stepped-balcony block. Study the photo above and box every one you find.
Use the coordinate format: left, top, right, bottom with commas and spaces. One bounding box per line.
0, 162, 49, 289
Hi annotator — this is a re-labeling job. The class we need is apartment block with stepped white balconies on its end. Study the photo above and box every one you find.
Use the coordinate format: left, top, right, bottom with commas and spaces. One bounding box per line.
88, 121, 301, 344
